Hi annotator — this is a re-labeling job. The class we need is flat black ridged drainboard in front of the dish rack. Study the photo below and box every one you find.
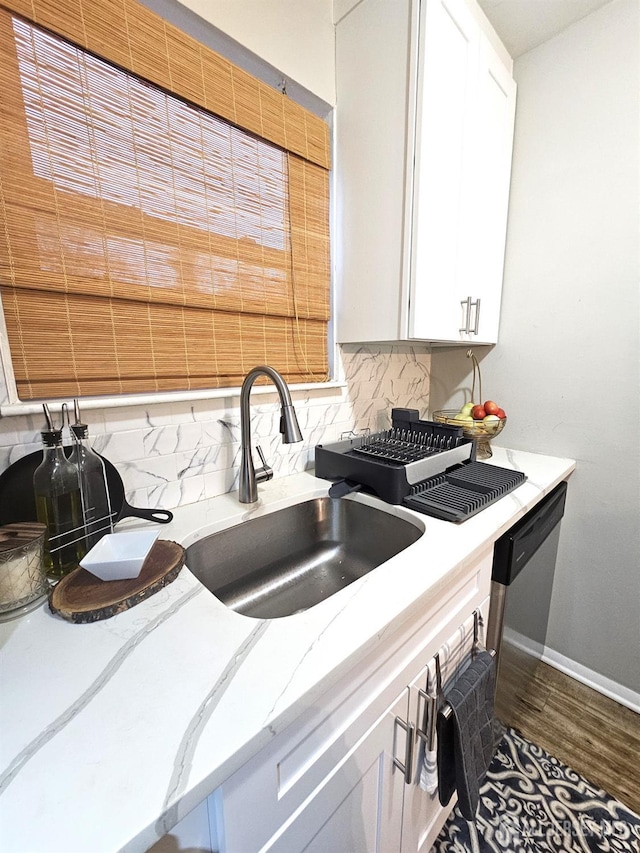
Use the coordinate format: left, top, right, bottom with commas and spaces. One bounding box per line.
402, 462, 526, 521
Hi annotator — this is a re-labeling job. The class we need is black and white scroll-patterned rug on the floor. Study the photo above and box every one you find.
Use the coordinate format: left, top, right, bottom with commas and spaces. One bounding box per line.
432, 729, 640, 853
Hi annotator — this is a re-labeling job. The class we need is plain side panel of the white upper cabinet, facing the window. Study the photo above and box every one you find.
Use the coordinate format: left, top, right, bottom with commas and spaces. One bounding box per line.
333, 0, 417, 342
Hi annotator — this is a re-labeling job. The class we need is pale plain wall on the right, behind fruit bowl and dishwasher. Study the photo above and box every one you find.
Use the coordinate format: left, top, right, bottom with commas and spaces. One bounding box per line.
431, 0, 640, 691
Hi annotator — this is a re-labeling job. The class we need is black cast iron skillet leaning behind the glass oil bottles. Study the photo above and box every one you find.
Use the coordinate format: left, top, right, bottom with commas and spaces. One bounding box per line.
0, 450, 173, 524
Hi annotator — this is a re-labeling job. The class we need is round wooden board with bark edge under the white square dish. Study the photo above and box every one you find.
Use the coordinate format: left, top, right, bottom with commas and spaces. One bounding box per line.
49, 539, 184, 623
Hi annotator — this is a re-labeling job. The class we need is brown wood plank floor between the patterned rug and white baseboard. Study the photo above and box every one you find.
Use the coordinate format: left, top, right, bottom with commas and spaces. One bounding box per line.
496, 644, 640, 814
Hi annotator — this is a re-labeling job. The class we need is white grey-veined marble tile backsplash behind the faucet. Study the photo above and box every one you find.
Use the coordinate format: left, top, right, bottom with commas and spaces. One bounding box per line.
0, 344, 431, 509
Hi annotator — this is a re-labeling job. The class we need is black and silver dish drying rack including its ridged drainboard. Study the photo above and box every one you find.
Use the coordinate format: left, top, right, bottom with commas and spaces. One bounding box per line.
315, 409, 526, 522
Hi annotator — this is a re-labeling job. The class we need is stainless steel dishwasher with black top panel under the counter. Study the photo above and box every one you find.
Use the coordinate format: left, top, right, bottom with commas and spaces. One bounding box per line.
487, 482, 567, 724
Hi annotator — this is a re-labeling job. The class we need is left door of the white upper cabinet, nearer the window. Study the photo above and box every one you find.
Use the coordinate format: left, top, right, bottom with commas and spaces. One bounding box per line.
409, 0, 480, 341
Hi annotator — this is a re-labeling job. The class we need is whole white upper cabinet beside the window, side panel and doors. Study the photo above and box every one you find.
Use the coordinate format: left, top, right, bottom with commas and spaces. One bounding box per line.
336, 0, 515, 343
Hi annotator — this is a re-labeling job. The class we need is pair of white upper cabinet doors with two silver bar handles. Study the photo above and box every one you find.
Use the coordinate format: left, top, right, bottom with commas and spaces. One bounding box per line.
409, 0, 516, 343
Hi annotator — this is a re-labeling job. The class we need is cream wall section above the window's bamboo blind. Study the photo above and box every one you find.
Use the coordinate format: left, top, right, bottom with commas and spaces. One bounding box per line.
174, 0, 336, 105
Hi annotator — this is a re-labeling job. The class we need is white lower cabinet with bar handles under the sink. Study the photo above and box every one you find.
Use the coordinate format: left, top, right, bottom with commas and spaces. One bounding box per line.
209, 553, 491, 853
